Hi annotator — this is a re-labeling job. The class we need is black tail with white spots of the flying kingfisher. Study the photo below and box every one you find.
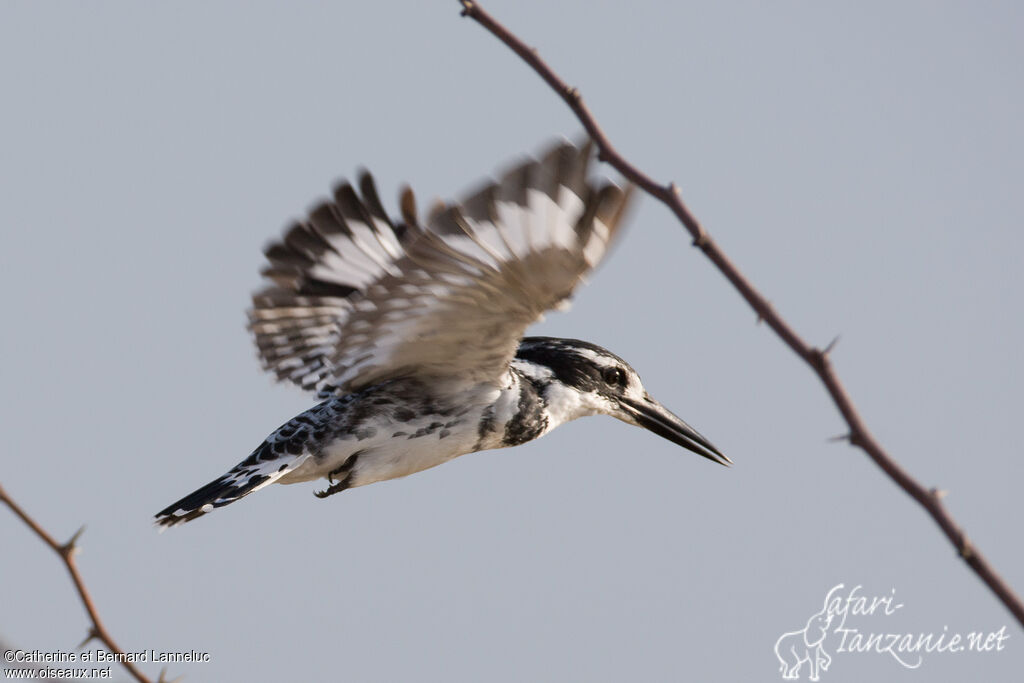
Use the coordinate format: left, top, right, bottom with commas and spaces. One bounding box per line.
155, 441, 308, 530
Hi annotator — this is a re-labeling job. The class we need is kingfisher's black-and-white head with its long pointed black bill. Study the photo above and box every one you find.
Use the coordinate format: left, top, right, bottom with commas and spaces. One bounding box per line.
516, 337, 732, 465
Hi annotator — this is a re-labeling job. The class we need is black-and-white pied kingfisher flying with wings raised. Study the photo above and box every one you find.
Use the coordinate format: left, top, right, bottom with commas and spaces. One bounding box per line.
156, 142, 731, 526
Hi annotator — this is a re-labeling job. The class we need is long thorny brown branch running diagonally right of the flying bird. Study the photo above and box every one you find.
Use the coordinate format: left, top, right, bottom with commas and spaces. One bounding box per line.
460, 0, 1024, 626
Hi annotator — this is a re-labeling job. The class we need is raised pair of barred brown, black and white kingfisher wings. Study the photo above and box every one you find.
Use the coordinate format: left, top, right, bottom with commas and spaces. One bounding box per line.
249, 142, 630, 392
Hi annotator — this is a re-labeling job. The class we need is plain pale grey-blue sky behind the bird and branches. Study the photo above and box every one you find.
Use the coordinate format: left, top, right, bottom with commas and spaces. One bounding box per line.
0, 0, 1024, 683
